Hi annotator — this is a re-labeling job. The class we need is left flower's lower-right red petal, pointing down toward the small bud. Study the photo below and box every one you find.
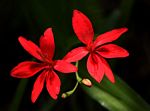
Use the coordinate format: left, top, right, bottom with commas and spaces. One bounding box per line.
46, 71, 61, 99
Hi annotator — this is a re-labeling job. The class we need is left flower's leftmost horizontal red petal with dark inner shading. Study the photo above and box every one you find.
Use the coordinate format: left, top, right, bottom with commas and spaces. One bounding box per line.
11, 61, 45, 78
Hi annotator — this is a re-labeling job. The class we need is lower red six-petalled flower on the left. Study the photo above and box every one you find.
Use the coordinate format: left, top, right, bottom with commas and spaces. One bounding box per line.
11, 28, 77, 103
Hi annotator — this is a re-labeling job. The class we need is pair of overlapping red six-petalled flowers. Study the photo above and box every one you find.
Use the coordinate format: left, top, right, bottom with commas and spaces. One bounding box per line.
11, 10, 129, 102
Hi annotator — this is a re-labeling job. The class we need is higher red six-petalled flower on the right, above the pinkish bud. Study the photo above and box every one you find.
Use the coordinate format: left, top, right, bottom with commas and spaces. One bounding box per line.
64, 10, 129, 83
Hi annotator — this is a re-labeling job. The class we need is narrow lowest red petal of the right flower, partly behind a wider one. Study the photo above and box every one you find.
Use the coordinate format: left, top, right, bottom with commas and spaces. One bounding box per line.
100, 57, 115, 83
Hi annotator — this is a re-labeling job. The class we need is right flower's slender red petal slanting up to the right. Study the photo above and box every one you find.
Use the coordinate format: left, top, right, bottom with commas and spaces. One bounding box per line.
93, 28, 128, 48
